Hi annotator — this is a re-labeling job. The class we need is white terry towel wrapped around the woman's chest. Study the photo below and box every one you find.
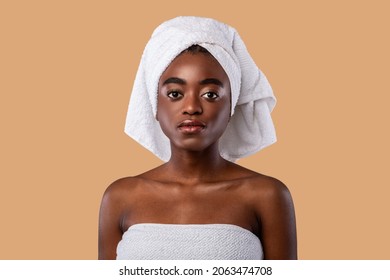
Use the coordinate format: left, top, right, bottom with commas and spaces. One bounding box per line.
116, 223, 264, 260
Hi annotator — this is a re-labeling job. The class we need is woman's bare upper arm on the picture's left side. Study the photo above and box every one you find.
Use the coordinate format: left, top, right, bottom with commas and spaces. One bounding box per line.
99, 183, 122, 260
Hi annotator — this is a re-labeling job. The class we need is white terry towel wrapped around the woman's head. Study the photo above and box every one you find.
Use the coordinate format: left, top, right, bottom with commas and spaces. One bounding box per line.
125, 16, 276, 161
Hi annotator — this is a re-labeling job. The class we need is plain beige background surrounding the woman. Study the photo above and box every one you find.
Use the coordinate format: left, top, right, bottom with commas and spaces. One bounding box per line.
0, 0, 390, 259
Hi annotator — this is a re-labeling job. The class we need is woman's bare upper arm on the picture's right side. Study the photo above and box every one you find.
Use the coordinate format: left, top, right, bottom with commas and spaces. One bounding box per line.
257, 178, 298, 260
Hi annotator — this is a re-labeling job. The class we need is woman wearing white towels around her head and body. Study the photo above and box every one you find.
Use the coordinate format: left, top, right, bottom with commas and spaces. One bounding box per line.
99, 17, 297, 259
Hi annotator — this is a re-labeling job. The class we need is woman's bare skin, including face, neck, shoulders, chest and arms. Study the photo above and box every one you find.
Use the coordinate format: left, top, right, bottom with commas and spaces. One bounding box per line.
99, 53, 297, 259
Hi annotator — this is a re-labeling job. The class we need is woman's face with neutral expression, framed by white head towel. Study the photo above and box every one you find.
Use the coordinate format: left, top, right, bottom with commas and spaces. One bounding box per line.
157, 53, 230, 151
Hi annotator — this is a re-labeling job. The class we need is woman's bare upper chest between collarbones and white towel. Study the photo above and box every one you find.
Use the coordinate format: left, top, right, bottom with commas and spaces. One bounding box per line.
123, 182, 258, 232
